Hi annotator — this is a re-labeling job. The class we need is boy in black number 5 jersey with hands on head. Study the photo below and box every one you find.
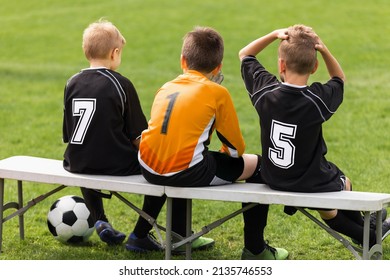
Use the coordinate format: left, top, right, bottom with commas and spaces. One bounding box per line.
239, 25, 390, 252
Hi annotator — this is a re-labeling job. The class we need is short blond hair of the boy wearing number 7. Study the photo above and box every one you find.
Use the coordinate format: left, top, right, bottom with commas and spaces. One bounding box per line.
82, 20, 126, 60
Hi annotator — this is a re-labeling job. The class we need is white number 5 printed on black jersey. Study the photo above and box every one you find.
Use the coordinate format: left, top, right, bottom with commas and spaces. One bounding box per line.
268, 120, 297, 169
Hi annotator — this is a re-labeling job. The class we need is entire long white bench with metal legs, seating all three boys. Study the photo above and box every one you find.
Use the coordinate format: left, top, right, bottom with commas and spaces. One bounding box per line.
0, 156, 390, 259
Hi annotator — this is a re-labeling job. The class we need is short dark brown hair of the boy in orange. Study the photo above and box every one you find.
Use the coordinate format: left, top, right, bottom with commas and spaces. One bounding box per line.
182, 26, 224, 73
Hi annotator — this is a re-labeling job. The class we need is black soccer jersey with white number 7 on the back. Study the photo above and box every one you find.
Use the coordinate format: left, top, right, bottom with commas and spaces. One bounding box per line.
63, 68, 147, 175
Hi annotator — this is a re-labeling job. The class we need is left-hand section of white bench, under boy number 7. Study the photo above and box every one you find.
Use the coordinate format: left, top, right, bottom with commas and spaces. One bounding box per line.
0, 156, 165, 253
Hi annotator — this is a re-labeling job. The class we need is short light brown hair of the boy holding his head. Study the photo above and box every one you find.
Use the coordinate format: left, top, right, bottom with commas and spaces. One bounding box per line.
279, 24, 318, 74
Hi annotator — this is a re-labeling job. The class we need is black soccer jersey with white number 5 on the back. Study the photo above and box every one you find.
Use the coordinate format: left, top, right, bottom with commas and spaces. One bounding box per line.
241, 56, 344, 192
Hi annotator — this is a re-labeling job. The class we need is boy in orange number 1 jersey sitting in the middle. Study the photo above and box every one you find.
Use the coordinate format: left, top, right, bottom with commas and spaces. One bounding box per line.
126, 27, 288, 259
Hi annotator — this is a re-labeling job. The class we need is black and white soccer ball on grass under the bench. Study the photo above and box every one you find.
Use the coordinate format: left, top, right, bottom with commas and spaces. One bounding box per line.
47, 195, 95, 243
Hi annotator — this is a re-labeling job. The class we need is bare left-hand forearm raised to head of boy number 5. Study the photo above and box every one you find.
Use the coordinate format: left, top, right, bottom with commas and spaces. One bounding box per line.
238, 28, 288, 60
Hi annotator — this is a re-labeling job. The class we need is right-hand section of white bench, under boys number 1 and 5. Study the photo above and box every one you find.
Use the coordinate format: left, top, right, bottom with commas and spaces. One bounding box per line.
165, 183, 390, 259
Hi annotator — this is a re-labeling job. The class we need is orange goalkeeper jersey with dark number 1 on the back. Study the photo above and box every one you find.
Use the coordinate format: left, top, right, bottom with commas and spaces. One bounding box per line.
139, 70, 245, 176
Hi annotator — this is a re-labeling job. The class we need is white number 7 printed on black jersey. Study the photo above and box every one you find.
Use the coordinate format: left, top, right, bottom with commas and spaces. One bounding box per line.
70, 98, 96, 145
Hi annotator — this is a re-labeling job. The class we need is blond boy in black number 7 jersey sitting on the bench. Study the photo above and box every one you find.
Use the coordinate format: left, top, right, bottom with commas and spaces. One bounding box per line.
63, 21, 147, 244
